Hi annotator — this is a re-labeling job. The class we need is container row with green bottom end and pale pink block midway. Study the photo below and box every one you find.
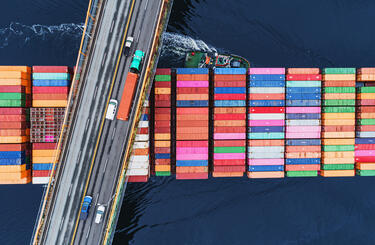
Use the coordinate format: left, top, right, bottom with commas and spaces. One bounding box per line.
285, 68, 322, 177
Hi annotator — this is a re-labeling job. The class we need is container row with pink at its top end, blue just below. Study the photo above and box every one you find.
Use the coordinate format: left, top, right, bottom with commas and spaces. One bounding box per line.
247, 68, 285, 178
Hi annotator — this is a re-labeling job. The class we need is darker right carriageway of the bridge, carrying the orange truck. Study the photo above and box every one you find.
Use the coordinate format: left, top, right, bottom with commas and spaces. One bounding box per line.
74, 1, 161, 244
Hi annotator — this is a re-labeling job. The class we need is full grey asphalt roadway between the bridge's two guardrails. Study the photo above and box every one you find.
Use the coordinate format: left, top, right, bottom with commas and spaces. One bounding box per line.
41, 0, 162, 245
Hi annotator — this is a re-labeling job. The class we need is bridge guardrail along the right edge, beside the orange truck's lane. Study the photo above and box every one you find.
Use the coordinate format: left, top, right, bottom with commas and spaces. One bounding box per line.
103, 0, 173, 244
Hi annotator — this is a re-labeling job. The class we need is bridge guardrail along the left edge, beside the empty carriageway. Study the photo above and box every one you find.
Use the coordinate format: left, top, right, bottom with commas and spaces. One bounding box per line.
30, 0, 103, 245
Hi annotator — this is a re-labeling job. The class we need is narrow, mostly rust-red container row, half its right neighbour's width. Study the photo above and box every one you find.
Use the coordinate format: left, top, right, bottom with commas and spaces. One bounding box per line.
154, 69, 172, 176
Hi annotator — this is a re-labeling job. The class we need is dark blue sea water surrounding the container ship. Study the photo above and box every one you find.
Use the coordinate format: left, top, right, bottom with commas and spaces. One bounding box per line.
0, 0, 375, 245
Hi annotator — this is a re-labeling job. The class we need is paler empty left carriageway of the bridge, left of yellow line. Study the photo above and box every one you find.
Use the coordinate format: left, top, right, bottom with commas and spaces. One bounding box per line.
42, 0, 135, 244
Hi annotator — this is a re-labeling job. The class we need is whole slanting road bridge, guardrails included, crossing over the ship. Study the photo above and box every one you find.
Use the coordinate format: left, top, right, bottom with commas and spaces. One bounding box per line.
31, 0, 173, 245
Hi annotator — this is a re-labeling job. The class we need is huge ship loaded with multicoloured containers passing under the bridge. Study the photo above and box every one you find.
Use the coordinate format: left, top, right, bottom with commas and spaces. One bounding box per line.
0, 66, 375, 184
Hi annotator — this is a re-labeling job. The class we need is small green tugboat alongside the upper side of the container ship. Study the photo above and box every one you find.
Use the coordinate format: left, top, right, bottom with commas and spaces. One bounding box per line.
185, 51, 250, 69
